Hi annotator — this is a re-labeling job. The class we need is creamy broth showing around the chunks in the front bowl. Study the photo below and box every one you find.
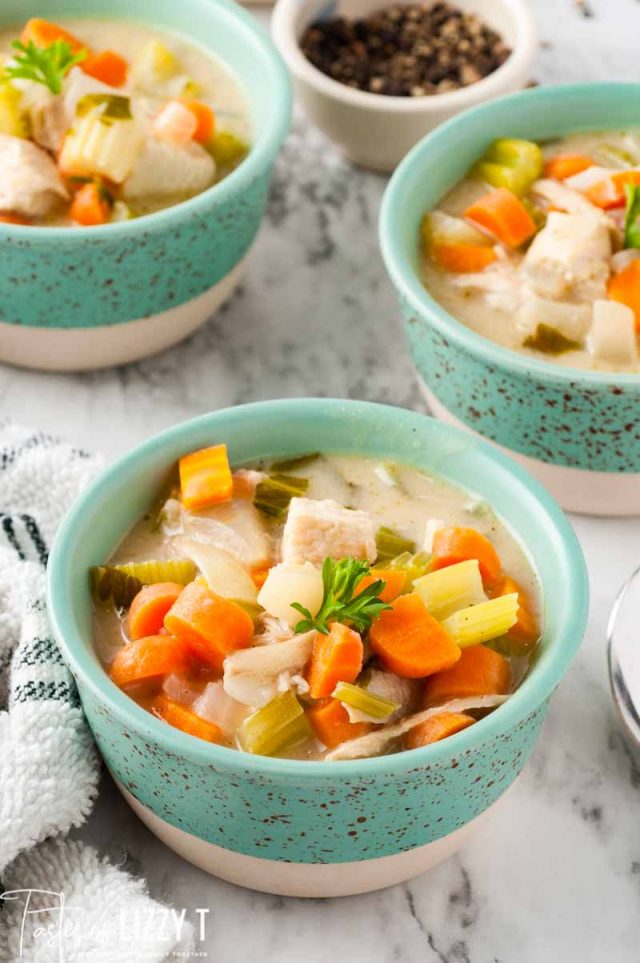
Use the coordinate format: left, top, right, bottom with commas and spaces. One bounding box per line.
94, 455, 541, 759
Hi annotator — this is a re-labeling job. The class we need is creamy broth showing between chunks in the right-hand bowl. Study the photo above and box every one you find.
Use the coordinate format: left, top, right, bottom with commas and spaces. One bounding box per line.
421, 131, 640, 372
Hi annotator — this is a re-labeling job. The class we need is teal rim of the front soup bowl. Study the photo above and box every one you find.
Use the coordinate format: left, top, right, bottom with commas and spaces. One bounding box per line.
47, 398, 589, 779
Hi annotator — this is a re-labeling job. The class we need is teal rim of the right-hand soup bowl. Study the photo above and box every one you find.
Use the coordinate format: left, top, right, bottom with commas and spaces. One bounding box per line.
378, 81, 640, 391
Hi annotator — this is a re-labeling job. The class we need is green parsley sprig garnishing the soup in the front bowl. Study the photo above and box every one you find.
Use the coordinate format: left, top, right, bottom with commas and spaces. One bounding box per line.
291, 558, 391, 635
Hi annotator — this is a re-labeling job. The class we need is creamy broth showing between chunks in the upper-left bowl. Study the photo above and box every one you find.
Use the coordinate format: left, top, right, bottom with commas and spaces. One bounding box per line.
0, 18, 252, 226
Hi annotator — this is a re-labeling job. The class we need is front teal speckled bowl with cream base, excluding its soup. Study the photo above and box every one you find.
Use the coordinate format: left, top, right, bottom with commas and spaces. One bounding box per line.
48, 399, 588, 896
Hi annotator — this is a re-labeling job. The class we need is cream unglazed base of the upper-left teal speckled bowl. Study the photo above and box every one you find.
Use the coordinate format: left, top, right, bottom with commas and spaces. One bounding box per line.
0, 258, 246, 371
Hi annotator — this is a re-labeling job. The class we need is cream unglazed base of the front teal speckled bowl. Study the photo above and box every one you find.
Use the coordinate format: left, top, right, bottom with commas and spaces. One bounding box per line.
116, 780, 503, 899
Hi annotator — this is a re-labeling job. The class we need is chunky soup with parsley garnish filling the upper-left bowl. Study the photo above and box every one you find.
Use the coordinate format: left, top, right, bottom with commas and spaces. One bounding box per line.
0, 19, 250, 226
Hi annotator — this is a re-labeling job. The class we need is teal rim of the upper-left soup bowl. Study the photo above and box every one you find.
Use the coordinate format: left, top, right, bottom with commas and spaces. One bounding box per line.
0, 0, 293, 244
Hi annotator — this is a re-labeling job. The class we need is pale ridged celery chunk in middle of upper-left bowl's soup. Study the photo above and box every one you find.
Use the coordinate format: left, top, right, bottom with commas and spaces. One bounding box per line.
60, 95, 144, 184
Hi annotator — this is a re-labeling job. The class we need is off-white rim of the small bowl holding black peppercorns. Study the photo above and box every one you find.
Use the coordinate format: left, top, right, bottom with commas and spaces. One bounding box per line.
271, 0, 537, 116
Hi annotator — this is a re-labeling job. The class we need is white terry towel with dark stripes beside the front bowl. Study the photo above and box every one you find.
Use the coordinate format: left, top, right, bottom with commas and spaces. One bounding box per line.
0, 424, 193, 963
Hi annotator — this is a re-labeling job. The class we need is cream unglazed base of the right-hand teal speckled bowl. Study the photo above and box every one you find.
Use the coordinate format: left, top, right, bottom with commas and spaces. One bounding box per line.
420, 381, 640, 516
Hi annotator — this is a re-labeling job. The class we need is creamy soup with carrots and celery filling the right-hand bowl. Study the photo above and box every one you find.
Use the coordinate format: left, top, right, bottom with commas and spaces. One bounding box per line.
421, 131, 640, 372
